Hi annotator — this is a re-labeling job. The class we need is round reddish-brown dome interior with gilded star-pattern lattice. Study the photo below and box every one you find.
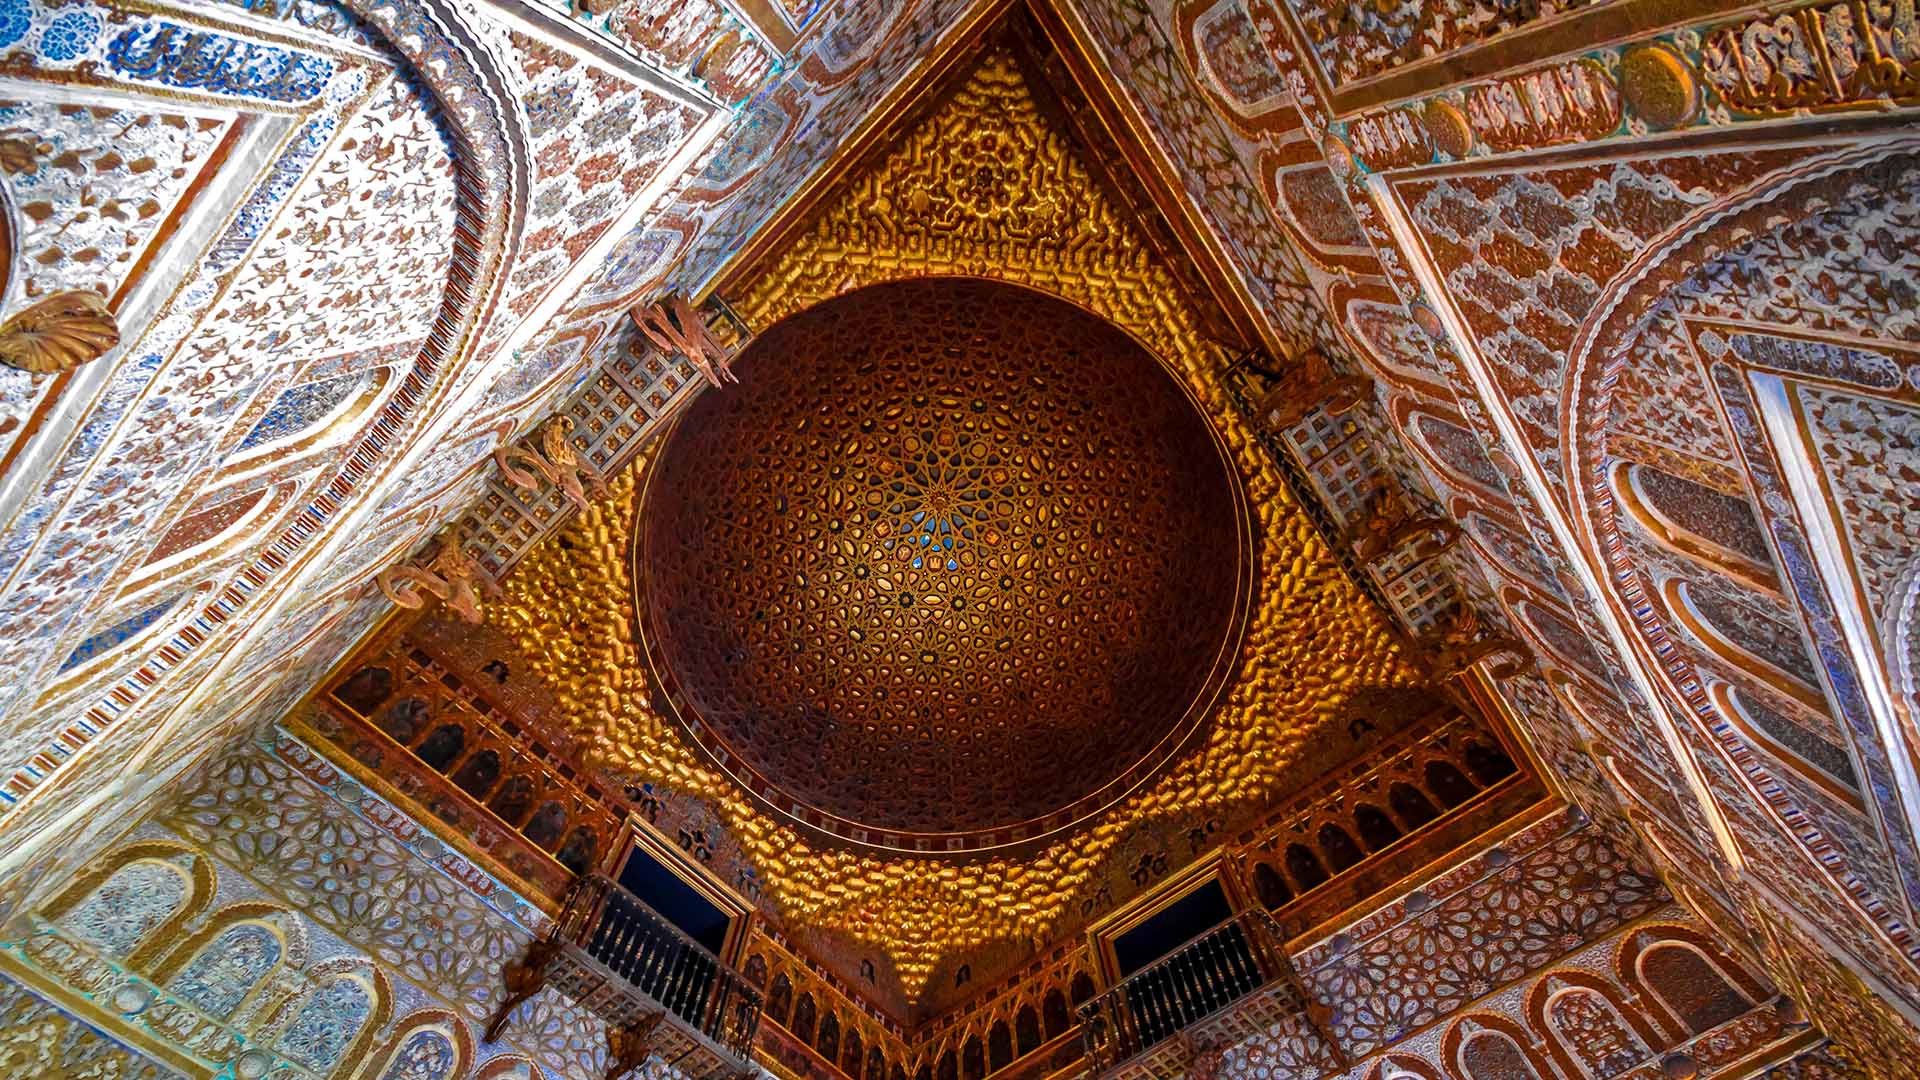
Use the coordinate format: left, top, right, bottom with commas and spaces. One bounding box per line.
634, 277, 1250, 849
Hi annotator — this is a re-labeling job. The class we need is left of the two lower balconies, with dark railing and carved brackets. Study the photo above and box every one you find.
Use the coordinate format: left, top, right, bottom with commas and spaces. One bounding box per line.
488, 874, 760, 1080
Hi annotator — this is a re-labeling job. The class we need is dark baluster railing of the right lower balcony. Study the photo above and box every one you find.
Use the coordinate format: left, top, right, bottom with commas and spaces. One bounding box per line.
1079, 909, 1296, 1074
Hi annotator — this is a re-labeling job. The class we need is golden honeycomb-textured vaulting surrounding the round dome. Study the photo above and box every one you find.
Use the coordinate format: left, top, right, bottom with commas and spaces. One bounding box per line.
488, 54, 1417, 1009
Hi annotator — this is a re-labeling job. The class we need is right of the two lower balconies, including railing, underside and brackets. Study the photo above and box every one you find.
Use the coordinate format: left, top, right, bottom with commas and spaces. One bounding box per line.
1079, 909, 1344, 1080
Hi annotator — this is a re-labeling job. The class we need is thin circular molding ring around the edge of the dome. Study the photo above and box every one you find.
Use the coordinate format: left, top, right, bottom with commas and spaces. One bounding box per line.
626, 273, 1261, 859
